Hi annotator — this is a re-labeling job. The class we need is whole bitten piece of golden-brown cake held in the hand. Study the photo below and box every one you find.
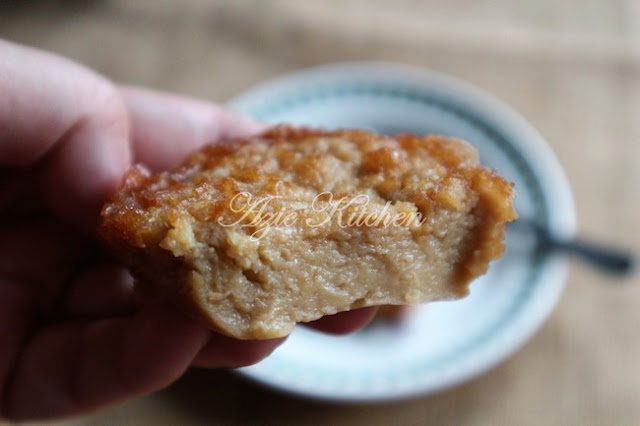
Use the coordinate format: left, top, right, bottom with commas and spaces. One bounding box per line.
99, 126, 516, 339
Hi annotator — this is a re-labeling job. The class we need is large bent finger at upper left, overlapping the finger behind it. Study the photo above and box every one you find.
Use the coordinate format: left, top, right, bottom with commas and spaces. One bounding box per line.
0, 40, 130, 233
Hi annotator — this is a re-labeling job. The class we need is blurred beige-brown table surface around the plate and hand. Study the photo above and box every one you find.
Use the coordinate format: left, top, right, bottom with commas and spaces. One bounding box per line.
0, 0, 640, 425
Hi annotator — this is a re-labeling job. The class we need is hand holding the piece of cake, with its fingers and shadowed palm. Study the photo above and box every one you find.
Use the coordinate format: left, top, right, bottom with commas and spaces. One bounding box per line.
0, 40, 375, 420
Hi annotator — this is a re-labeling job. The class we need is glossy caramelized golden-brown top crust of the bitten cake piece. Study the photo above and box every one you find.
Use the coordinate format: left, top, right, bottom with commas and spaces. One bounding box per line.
101, 126, 515, 247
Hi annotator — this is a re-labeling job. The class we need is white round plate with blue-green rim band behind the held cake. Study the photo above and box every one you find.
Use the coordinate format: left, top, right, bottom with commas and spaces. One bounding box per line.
231, 63, 575, 401
